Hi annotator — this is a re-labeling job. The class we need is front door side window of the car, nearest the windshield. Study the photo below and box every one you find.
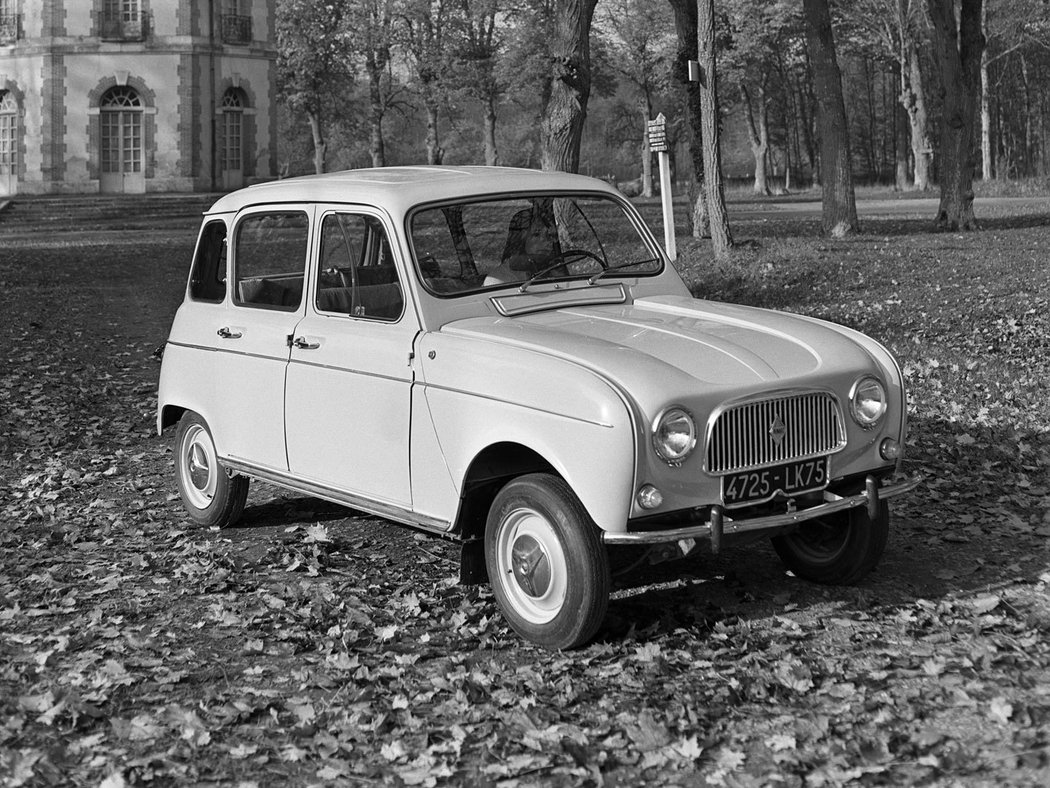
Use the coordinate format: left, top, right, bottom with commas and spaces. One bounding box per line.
315, 213, 404, 320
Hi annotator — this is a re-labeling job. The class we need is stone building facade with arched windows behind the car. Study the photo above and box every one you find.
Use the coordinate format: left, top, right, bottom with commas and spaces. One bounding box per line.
0, 0, 277, 196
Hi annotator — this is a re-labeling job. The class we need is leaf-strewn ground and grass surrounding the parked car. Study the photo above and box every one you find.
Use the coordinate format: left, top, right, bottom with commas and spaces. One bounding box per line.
0, 193, 1050, 788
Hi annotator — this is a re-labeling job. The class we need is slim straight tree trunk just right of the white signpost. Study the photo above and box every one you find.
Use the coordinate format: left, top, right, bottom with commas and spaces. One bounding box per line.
696, 0, 733, 260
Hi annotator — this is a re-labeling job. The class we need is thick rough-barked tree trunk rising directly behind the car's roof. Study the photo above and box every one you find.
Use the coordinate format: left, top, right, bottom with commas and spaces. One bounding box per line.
541, 0, 597, 172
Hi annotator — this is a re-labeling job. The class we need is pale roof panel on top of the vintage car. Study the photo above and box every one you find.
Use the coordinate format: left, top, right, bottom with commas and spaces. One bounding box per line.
202, 165, 618, 213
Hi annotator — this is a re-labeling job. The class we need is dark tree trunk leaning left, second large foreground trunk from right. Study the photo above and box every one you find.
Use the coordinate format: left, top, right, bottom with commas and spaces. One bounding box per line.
802, 0, 860, 237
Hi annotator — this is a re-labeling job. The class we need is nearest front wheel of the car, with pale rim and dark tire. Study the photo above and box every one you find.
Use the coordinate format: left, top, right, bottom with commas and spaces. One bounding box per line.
485, 474, 611, 649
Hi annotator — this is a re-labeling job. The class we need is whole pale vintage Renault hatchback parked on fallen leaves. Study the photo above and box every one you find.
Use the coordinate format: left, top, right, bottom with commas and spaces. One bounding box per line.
158, 167, 918, 648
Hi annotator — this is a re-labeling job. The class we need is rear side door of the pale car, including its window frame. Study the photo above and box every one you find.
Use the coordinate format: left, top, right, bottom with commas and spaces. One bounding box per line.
215, 206, 313, 472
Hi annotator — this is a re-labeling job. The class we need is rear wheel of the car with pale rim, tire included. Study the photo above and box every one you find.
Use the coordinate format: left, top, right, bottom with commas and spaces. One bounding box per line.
175, 411, 248, 528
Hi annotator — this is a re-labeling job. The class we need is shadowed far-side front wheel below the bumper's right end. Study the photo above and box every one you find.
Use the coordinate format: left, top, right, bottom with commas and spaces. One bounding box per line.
773, 503, 889, 585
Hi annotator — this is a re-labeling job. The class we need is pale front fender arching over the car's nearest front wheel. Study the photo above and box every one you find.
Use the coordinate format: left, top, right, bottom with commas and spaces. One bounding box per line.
419, 333, 638, 532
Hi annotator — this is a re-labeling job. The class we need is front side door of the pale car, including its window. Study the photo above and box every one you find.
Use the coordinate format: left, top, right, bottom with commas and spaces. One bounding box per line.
285, 208, 419, 509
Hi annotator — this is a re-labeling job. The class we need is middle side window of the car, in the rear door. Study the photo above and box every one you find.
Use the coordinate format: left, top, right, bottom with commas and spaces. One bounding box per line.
233, 211, 310, 312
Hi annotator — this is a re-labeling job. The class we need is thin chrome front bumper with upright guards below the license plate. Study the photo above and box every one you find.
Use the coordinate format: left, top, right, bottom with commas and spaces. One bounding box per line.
602, 476, 922, 552
